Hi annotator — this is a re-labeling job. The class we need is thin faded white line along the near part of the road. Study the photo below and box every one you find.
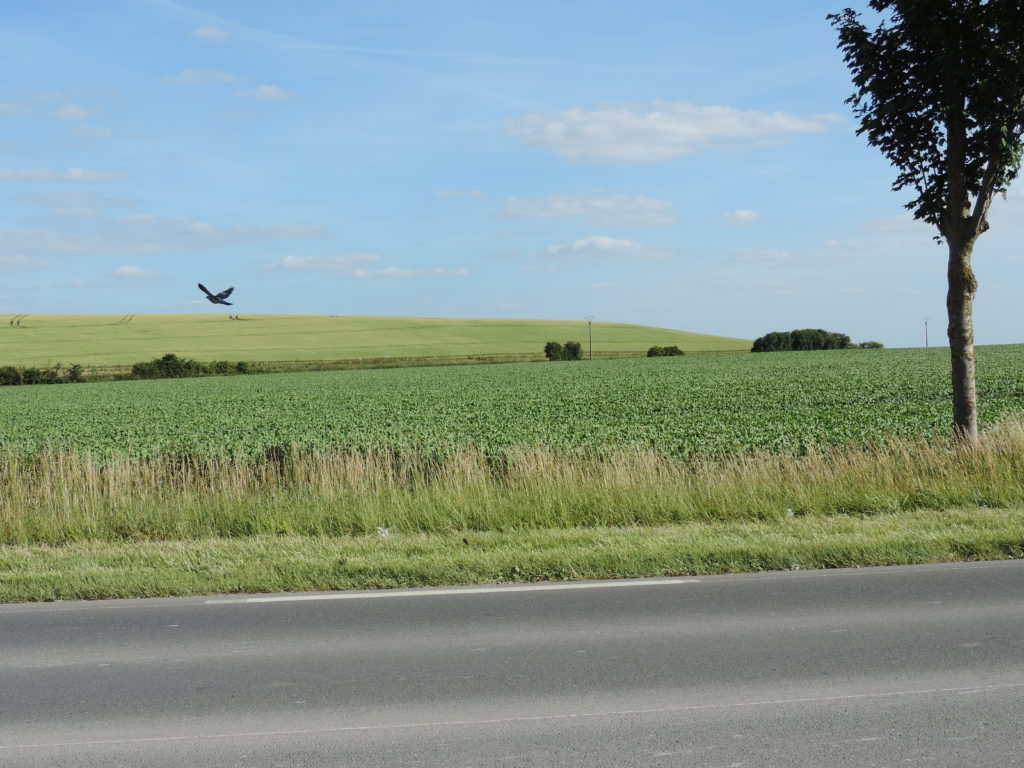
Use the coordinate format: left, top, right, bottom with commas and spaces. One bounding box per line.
0, 683, 1024, 751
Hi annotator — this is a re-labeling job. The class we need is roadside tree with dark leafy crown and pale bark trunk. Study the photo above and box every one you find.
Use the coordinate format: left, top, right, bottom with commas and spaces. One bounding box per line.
828, 0, 1024, 445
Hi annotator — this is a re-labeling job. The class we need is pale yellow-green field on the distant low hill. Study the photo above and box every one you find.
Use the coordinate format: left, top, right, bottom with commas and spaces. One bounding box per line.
0, 313, 751, 366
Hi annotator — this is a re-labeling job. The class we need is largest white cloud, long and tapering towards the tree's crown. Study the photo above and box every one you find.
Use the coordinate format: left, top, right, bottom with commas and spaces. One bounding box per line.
506, 100, 835, 163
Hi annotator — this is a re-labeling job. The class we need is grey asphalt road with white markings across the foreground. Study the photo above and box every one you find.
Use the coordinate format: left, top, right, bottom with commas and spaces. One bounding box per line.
0, 561, 1024, 768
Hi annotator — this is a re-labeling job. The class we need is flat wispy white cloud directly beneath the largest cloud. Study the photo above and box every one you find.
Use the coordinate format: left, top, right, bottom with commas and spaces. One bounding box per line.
503, 189, 676, 226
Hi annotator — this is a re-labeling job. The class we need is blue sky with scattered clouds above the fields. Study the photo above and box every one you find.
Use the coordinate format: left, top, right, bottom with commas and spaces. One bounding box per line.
0, 0, 1024, 346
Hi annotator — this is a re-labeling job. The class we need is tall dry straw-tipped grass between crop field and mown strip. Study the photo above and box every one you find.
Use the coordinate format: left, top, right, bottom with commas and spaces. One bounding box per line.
0, 421, 1024, 546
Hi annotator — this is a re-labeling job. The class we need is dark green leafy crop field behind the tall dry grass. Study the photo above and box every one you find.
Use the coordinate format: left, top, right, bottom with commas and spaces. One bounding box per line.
0, 345, 1024, 456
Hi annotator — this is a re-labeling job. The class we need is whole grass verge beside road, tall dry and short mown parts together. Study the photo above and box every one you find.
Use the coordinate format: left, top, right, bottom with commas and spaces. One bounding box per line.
0, 421, 1024, 601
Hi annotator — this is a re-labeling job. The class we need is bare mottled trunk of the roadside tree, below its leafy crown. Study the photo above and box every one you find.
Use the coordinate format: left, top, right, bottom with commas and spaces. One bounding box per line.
946, 238, 978, 447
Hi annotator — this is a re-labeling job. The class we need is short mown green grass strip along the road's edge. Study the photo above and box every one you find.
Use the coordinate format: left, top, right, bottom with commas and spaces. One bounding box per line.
0, 508, 1024, 602
